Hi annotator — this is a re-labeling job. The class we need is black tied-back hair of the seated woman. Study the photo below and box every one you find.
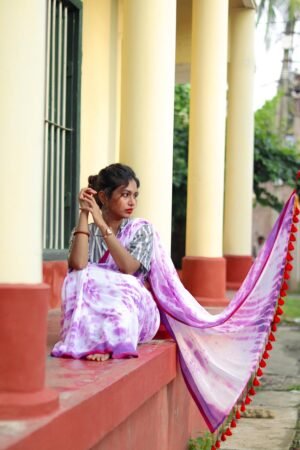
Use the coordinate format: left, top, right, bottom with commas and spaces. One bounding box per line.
88, 163, 140, 206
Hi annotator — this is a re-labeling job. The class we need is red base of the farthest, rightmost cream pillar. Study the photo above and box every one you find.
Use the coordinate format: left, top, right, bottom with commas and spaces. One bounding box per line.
224, 255, 253, 290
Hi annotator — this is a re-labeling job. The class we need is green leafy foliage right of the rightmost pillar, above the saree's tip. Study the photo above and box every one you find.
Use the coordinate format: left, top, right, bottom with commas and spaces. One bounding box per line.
253, 95, 300, 211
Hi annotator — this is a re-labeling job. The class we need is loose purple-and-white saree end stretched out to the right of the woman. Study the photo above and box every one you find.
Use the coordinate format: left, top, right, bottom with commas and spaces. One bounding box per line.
149, 195, 295, 431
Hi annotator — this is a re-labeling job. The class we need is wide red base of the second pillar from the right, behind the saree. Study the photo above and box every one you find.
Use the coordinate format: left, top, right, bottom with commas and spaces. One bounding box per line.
182, 256, 229, 306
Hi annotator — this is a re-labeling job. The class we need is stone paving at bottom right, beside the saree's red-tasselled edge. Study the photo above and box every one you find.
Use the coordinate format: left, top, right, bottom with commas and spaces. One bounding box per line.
221, 325, 300, 450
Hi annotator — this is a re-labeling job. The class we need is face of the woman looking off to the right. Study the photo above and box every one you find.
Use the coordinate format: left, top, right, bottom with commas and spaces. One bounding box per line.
104, 180, 138, 220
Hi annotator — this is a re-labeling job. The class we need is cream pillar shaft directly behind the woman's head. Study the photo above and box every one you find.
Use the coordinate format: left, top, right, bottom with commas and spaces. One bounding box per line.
120, 0, 176, 247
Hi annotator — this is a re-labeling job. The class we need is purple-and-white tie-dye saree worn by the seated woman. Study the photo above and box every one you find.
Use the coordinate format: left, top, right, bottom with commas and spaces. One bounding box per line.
52, 194, 296, 432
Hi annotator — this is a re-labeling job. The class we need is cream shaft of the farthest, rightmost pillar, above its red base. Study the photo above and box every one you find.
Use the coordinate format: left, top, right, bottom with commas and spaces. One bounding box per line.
224, 8, 255, 256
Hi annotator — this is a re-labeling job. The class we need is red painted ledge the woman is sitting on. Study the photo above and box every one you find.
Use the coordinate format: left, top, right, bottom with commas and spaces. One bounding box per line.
0, 341, 176, 450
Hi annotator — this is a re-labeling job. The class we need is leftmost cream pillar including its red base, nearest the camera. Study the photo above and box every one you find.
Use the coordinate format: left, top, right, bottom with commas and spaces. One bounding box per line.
0, 0, 59, 420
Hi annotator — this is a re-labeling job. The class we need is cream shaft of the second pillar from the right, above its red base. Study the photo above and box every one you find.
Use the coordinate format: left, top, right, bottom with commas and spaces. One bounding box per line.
186, 0, 228, 257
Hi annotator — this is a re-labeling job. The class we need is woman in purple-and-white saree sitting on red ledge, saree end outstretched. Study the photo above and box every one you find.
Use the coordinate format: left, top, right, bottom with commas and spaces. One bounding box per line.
52, 164, 300, 432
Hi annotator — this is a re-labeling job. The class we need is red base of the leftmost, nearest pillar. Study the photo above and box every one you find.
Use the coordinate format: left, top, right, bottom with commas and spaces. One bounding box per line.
0, 284, 58, 419
